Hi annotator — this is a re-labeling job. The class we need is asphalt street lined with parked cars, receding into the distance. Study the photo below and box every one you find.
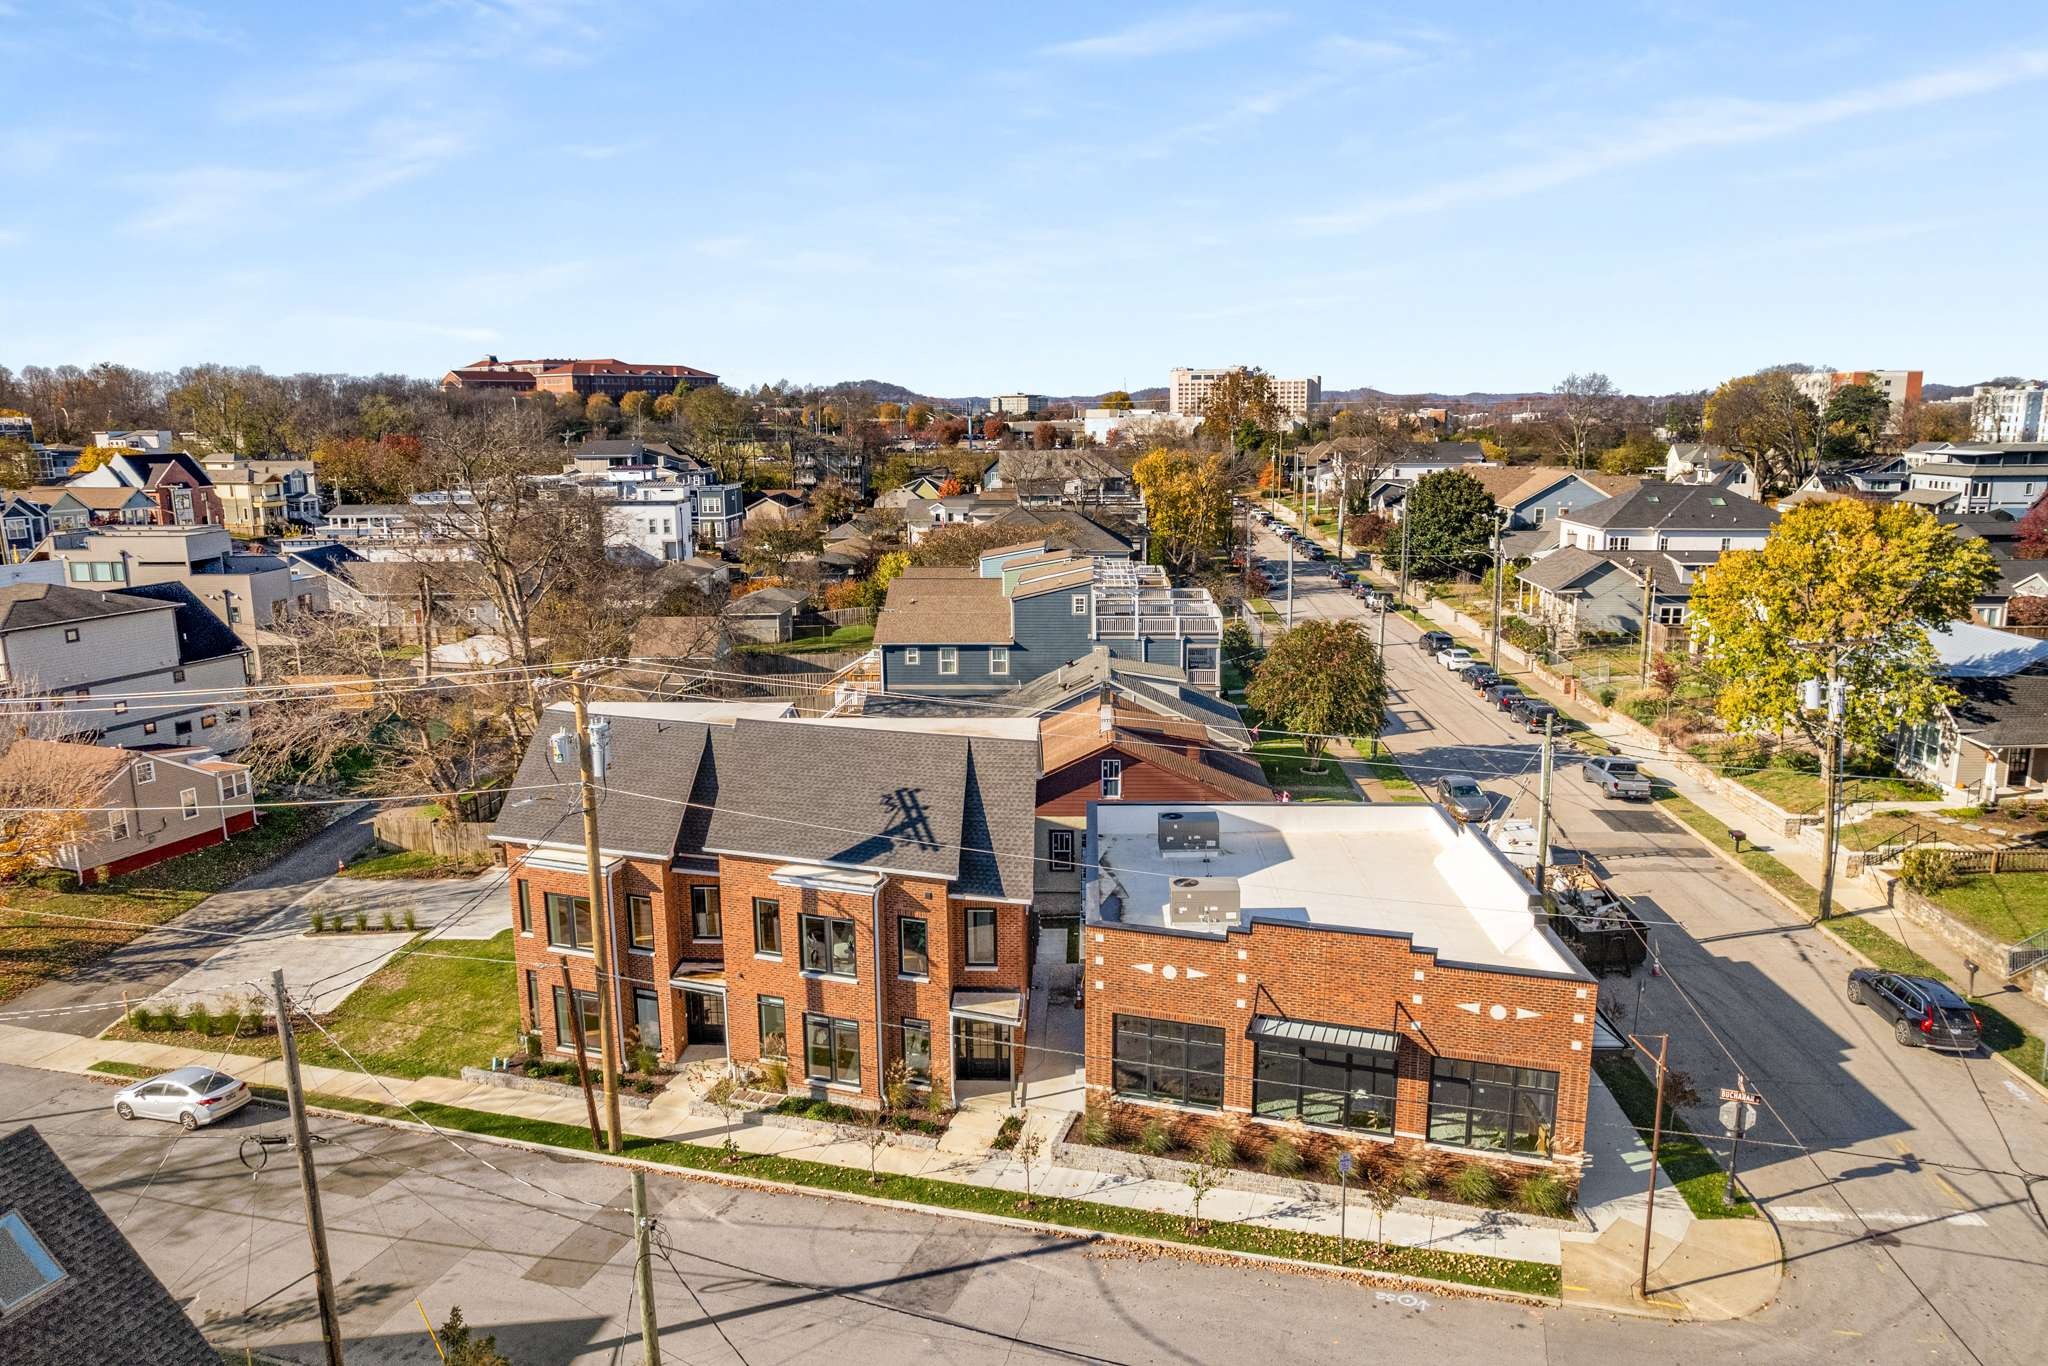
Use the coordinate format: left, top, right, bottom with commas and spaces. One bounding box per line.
1257, 532, 2048, 1362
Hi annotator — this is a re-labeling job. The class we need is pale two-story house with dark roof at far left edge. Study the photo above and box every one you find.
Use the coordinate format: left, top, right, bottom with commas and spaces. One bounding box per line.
0, 584, 250, 754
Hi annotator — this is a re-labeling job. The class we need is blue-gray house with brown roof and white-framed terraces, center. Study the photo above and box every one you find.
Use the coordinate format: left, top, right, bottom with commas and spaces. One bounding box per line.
874, 541, 1223, 696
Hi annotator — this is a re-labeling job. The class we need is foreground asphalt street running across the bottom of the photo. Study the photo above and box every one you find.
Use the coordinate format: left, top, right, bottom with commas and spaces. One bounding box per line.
0, 1065, 2038, 1366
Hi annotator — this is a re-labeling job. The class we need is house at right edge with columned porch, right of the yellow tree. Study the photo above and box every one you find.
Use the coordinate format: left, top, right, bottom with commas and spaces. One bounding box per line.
1896, 621, 2048, 805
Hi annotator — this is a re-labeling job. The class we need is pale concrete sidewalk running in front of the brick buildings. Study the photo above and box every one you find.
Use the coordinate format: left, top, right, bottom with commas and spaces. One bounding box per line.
0, 1026, 1778, 1317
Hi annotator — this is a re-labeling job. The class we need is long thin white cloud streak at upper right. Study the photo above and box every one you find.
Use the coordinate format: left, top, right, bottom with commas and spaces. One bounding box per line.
1300, 49, 2048, 233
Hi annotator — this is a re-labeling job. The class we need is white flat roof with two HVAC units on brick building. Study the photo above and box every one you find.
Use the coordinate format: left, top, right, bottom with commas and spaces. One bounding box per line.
1085, 803, 1585, 977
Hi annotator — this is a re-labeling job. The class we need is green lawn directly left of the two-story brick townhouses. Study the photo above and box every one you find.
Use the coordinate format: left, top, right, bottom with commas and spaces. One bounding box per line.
106, 930, 518, 1077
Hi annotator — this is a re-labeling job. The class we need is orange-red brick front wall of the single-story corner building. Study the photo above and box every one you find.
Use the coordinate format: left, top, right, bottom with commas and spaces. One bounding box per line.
1081, 922, 1597, 1159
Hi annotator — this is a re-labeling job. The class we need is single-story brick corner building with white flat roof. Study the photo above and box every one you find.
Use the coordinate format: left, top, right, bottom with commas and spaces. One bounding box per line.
1081, 803, 1597, 1163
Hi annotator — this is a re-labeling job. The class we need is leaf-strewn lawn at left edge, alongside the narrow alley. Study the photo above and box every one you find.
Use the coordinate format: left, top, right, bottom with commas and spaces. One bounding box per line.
0, 807, 319, 1001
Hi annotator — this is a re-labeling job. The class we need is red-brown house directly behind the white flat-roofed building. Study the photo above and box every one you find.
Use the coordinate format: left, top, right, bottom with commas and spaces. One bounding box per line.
1036, 692, 1274, 922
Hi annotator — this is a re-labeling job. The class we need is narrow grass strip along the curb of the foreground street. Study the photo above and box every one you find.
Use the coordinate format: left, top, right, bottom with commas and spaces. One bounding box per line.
92, 1061, 1563, 1298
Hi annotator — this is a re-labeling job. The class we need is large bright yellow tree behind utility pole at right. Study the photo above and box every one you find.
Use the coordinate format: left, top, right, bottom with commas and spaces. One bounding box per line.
1692, 498, 1999, 915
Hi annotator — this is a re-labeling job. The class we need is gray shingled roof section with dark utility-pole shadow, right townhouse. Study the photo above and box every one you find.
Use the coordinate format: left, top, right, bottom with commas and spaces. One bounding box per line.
705, 719, 1038, 899
